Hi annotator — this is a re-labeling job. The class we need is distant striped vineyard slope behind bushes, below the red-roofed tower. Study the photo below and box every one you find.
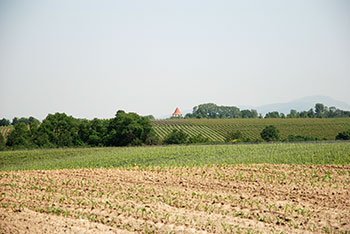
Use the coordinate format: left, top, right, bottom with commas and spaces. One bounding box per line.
152, 118, 350, 142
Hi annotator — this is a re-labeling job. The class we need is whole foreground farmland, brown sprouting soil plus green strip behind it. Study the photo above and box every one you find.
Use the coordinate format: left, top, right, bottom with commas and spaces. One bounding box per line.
0, 142, 350, 233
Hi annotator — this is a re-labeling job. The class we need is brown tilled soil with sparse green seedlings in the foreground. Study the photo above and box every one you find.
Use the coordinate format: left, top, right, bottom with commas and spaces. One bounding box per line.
0, 164, 350, 233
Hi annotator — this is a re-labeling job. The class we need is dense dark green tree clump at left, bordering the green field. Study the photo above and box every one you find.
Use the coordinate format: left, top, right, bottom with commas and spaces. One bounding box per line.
0, 110, 159, 149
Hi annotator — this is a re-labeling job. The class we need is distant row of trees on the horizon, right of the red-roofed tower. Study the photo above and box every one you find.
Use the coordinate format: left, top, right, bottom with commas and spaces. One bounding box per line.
185, 103, 350, 119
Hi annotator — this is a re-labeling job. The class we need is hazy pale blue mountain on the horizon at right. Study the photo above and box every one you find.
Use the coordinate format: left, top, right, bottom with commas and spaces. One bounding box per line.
249, 96, 350, 115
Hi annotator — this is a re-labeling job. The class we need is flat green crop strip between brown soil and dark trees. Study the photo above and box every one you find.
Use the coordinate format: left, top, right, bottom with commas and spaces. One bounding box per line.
0, 142, 350, 171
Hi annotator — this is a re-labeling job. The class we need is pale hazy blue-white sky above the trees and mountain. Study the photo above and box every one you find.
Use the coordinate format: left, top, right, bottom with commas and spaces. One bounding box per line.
0, 0, 350, 120
